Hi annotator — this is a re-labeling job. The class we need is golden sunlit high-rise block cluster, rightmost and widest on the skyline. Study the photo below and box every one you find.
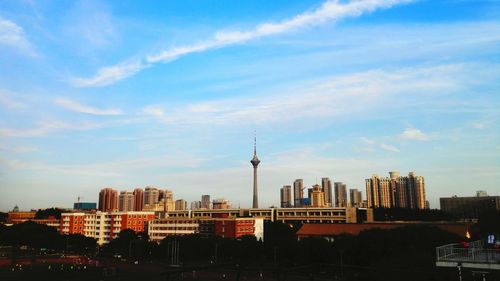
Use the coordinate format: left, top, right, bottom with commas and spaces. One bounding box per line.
365, 171, 429, 209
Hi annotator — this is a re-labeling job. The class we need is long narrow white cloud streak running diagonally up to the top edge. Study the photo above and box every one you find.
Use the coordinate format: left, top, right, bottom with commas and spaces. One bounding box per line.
72, 0, 411, 87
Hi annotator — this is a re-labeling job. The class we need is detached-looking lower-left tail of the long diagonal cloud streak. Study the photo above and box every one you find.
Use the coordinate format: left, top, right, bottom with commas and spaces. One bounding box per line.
70, 61, 149, 88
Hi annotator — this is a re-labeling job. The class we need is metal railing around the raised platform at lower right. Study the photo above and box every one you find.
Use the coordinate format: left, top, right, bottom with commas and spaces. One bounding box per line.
436, 240, 500, 263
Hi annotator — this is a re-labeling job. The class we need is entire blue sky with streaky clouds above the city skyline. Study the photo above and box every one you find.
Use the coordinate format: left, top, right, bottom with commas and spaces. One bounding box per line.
0, 0, 500, 211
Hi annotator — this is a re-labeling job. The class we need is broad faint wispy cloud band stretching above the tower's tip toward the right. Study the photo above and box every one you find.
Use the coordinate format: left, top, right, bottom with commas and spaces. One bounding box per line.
142, 65, 467, 126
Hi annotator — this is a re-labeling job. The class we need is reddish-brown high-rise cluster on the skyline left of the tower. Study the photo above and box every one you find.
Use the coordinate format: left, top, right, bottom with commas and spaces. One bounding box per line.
95, 186, 231, 212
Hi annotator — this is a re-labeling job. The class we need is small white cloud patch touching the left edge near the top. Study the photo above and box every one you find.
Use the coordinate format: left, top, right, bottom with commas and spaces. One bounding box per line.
0, 17, 33, 53
